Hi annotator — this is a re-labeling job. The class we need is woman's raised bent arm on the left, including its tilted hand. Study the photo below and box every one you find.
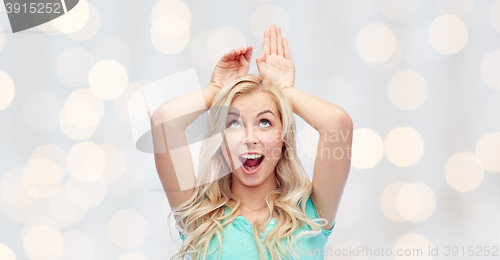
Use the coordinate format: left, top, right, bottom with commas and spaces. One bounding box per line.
151, 46, 252, 211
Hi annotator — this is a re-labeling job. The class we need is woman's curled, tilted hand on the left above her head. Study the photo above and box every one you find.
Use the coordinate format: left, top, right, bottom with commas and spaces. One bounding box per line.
209, 45, 253, 90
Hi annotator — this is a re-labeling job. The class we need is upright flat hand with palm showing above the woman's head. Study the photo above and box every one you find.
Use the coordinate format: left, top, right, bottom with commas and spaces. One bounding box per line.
256, 24, 295, 89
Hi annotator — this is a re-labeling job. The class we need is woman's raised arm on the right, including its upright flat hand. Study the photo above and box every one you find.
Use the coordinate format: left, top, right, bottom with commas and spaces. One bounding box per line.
257, 24, 353, 230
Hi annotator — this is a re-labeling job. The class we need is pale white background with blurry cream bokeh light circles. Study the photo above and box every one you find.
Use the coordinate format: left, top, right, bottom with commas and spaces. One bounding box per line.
0, 0, 500, 260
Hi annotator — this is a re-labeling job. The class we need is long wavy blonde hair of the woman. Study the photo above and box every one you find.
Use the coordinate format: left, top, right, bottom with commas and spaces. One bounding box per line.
169, 74, 326, 260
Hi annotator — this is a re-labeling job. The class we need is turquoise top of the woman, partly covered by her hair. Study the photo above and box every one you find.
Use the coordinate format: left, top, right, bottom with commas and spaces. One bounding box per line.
179, 197, 335, 260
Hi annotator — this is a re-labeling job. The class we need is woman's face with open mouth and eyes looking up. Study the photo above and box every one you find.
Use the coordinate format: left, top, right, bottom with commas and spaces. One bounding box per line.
221, 91, 283, 186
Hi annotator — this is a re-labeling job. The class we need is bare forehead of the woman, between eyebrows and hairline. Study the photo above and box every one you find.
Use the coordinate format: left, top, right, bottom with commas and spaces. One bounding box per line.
231, 91, 278, 116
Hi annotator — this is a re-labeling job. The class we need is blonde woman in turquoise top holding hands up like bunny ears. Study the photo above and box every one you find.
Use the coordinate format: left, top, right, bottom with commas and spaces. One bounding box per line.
151, 24, 353, 260
